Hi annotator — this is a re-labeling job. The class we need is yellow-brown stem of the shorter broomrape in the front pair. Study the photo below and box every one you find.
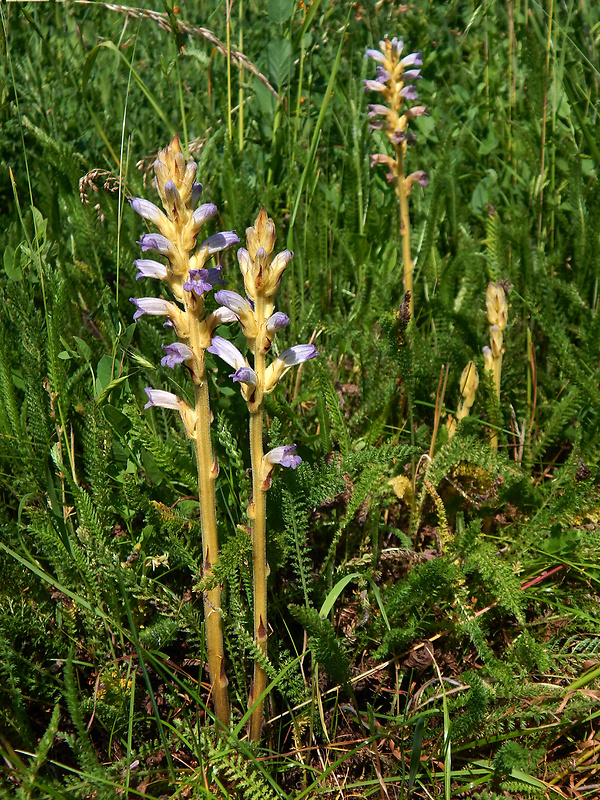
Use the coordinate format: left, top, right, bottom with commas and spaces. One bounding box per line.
249, 302, 267, 742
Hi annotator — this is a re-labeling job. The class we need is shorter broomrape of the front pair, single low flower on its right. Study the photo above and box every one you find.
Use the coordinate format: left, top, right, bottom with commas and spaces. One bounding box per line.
208, 208, 317, 741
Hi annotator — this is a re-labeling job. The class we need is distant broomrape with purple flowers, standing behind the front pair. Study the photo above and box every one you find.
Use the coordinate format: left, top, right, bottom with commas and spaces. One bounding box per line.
364, 36, 428, 316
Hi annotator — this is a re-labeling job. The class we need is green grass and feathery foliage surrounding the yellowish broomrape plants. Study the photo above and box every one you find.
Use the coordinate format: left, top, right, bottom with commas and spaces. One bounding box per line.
0, 0, 600, 800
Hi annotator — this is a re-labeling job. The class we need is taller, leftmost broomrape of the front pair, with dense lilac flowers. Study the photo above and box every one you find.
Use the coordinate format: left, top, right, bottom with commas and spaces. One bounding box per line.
131, 137, 239, 727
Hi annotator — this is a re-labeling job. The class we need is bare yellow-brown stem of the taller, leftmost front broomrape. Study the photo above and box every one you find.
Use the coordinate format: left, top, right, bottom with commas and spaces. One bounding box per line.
188, 308, 229, 729
